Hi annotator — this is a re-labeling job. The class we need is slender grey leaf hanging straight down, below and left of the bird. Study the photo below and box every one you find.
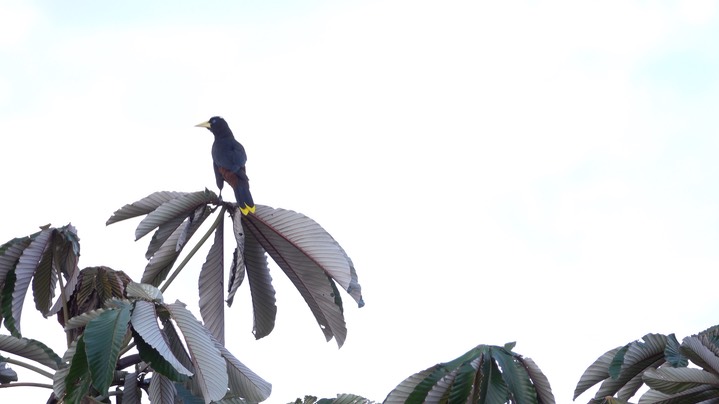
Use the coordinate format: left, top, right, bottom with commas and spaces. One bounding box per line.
198, 212, 225, 344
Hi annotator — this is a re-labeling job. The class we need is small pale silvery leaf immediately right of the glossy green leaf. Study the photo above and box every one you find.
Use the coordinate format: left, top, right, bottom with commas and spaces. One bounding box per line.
131, 300, 192, 376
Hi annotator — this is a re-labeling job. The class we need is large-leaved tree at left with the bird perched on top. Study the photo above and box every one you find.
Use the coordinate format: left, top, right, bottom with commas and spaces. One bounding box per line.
0, 190, 364, 404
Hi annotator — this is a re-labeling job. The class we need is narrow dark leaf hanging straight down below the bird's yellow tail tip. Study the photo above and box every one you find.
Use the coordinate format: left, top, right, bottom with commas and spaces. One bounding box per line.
242, 226, 277, 339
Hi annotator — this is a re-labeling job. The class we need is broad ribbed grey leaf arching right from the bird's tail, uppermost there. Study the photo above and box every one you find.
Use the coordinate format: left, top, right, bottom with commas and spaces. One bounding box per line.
243, 205, 362, 304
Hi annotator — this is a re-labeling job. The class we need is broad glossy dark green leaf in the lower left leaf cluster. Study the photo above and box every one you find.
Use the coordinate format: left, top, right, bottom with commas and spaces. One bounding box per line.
84, 304, 130, 394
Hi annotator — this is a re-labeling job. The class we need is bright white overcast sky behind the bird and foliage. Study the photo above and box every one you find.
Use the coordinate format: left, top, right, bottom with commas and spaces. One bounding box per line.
0, 0, 719, 403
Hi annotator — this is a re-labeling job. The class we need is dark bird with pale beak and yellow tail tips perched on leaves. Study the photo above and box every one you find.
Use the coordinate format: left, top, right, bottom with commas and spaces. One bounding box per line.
195, 116, 255, 215
